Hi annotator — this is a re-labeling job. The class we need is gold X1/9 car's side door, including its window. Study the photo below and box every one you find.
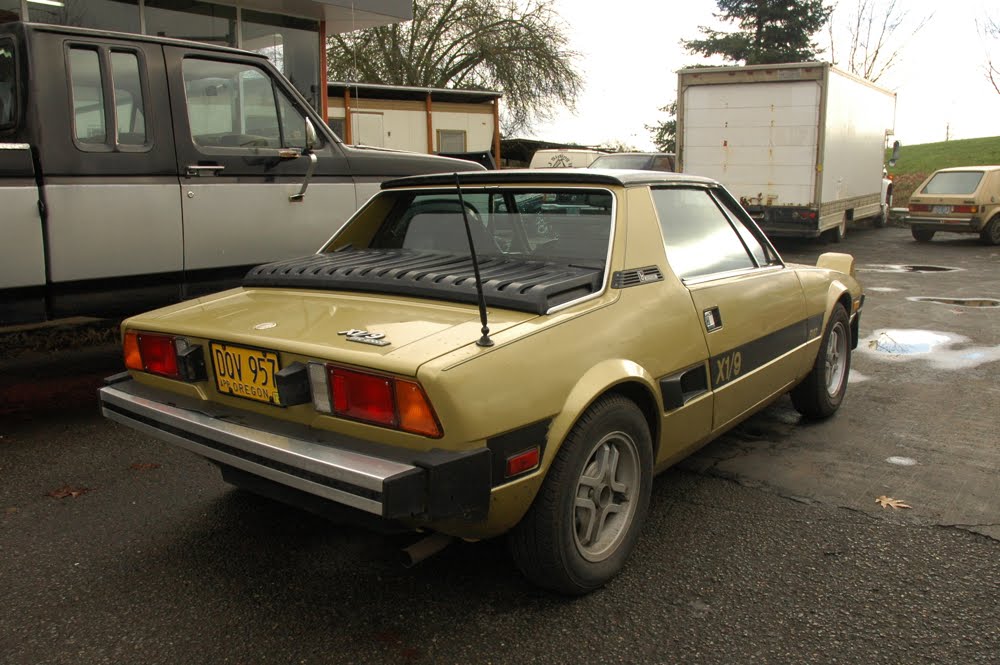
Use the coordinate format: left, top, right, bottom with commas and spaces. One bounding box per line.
653, 186, 808, 430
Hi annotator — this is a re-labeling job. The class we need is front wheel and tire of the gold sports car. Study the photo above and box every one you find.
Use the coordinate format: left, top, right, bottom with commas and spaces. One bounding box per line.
792, 305, 852, 420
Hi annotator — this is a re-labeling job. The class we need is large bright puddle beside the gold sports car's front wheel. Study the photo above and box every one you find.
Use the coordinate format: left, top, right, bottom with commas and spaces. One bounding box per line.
858, 329, 1000, 369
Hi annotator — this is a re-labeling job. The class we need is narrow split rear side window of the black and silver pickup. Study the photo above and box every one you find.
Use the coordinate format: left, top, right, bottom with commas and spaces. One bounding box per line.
68, 45, 149, 152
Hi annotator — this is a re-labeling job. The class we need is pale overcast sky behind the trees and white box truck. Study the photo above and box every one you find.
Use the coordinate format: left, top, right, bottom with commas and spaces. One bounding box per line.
525, 0, 1000, 150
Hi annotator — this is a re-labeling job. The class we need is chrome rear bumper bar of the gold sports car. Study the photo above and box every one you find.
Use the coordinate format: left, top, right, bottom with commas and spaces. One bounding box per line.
100, 386, 416, 515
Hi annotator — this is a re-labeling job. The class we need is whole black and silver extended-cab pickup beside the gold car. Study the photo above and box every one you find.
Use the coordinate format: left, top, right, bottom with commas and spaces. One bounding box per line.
0, 22, 482, 327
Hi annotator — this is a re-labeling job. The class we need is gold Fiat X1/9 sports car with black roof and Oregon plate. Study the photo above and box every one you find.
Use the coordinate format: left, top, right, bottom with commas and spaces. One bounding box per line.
101, 169, 864, 594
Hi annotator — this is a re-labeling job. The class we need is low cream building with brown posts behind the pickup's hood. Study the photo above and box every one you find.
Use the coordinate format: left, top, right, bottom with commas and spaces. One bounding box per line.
327, 81, 502, 164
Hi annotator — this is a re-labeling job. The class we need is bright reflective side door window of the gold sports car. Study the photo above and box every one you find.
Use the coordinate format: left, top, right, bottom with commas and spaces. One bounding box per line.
653, 189, 755, 279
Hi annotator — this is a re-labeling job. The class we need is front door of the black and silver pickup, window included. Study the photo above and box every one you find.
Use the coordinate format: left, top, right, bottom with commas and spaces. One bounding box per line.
164, 46, 358, 295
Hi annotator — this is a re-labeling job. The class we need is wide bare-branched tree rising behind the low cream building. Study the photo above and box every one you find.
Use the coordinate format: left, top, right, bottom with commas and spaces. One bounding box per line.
327, 0, 582, 133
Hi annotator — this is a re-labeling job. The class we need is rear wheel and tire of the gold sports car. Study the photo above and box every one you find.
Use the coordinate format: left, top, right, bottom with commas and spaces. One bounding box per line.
507, 395, 653, 596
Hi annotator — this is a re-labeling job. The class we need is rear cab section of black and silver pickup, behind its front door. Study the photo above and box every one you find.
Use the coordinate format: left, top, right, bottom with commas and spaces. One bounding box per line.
29, 32, 182, 317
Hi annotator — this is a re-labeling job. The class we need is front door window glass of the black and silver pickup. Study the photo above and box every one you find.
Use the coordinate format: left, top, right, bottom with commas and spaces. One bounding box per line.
184, 58, 316, 151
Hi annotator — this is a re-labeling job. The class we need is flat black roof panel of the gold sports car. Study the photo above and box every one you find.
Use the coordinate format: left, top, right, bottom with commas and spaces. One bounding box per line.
382, 168, 718, 189
